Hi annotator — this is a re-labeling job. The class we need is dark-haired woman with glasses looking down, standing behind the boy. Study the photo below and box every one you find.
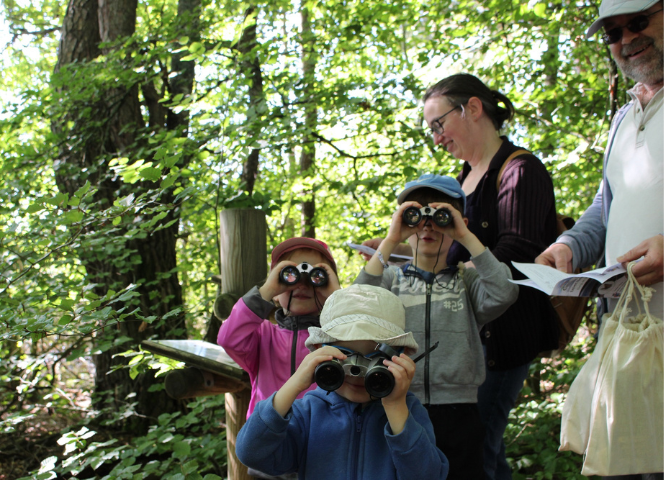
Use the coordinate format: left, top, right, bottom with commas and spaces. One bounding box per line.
423, 74, 558, 480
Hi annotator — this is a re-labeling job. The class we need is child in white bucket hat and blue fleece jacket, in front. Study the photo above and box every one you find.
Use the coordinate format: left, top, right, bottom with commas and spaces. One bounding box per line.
236, 285, 448, 480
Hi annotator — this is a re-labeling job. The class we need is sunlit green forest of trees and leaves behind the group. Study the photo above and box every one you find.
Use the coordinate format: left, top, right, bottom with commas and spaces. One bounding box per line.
0, 0, 630, 480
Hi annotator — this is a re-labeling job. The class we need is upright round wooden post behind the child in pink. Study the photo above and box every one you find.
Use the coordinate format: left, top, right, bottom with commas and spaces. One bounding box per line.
219, 208, 267, 480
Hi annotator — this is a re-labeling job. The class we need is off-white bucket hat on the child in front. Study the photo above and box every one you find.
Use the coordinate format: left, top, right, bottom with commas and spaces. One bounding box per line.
304, 285, 418, 355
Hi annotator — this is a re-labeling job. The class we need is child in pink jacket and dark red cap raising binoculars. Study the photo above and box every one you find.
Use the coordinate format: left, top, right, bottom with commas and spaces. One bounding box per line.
217, 237, 340, 418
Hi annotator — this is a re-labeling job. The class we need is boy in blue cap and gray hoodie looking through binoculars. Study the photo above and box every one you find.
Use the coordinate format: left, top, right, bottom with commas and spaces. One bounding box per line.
355, 174, 518, 480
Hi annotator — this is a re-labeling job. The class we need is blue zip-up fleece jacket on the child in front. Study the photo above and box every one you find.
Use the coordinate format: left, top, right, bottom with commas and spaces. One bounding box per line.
236, 388, 449, 480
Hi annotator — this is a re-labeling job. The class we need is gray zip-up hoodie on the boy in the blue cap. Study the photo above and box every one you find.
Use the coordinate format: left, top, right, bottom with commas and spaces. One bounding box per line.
355, 249, 519, 405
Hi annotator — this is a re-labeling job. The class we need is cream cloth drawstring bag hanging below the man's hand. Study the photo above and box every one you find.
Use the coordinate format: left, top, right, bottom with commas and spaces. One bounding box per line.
561, 264, 664, 475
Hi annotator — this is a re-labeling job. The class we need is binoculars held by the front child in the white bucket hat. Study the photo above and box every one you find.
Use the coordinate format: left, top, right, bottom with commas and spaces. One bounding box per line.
314, 343, 399, 398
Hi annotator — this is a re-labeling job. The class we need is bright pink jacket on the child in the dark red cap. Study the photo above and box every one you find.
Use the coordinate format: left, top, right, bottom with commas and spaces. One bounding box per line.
217, 287, 320, 418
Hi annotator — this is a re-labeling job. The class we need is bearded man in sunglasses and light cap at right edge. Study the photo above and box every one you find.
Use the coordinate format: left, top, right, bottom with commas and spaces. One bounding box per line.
535, 0, 664, 480
